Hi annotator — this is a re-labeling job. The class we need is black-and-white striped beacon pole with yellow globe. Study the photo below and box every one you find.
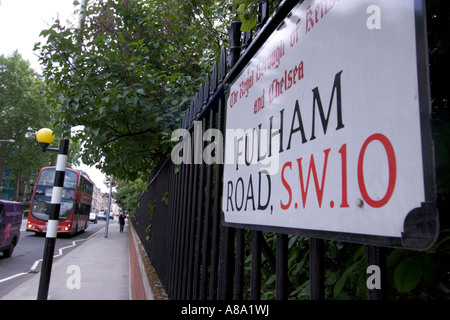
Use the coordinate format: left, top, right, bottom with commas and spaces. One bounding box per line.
36, 128, 69, 300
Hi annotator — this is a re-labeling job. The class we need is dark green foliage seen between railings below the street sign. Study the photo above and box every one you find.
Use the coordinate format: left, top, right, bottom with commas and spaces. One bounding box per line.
244, 230, 450, 300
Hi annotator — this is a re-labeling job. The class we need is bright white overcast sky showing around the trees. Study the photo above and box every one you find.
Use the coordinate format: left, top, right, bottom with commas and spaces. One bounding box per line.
0, 0, 109, 192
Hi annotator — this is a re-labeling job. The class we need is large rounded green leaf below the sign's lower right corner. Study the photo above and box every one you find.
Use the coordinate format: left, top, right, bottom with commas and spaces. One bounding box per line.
394, 258, 422, 292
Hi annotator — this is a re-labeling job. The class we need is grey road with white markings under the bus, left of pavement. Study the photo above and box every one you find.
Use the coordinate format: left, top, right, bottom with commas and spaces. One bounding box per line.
0, 219, 112, 297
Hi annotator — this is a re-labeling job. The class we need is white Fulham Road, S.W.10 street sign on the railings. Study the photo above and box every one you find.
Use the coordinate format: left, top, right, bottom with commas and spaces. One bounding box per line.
222, 0, 439, 249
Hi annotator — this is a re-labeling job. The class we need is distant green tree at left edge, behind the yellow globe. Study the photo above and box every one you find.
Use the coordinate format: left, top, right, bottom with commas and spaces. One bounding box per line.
0, 51, 79, 200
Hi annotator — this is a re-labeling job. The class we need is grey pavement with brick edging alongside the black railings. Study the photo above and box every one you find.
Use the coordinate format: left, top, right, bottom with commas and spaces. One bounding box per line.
1, 221, 153, 300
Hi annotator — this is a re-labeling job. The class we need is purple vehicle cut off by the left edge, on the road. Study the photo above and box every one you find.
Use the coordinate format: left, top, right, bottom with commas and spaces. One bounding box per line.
0, 200, 23, 258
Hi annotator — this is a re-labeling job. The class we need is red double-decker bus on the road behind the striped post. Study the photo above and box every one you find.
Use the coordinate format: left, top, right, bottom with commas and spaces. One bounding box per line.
27, 167, 94, 235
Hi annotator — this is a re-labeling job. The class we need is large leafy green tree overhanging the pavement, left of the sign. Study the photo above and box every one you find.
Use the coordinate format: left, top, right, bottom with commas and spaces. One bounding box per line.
36, 0, 228, 180
